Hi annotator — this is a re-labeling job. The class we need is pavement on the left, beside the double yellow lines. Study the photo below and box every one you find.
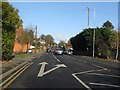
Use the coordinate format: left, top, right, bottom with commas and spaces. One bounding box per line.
0, 51, 44, 81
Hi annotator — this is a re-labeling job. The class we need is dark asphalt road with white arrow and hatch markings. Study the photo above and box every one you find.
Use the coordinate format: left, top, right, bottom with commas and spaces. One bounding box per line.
4, 53, 120, 90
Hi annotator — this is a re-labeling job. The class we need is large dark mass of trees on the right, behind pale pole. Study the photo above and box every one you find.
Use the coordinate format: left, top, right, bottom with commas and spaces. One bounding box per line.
70, 21, 117, 57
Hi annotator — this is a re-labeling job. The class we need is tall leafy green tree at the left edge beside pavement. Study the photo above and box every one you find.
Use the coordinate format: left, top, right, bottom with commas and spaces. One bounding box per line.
2, 2, 22, 60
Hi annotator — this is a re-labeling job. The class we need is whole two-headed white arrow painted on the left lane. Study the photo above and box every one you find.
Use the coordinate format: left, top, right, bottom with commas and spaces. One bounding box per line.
38, 62, 67, 77
